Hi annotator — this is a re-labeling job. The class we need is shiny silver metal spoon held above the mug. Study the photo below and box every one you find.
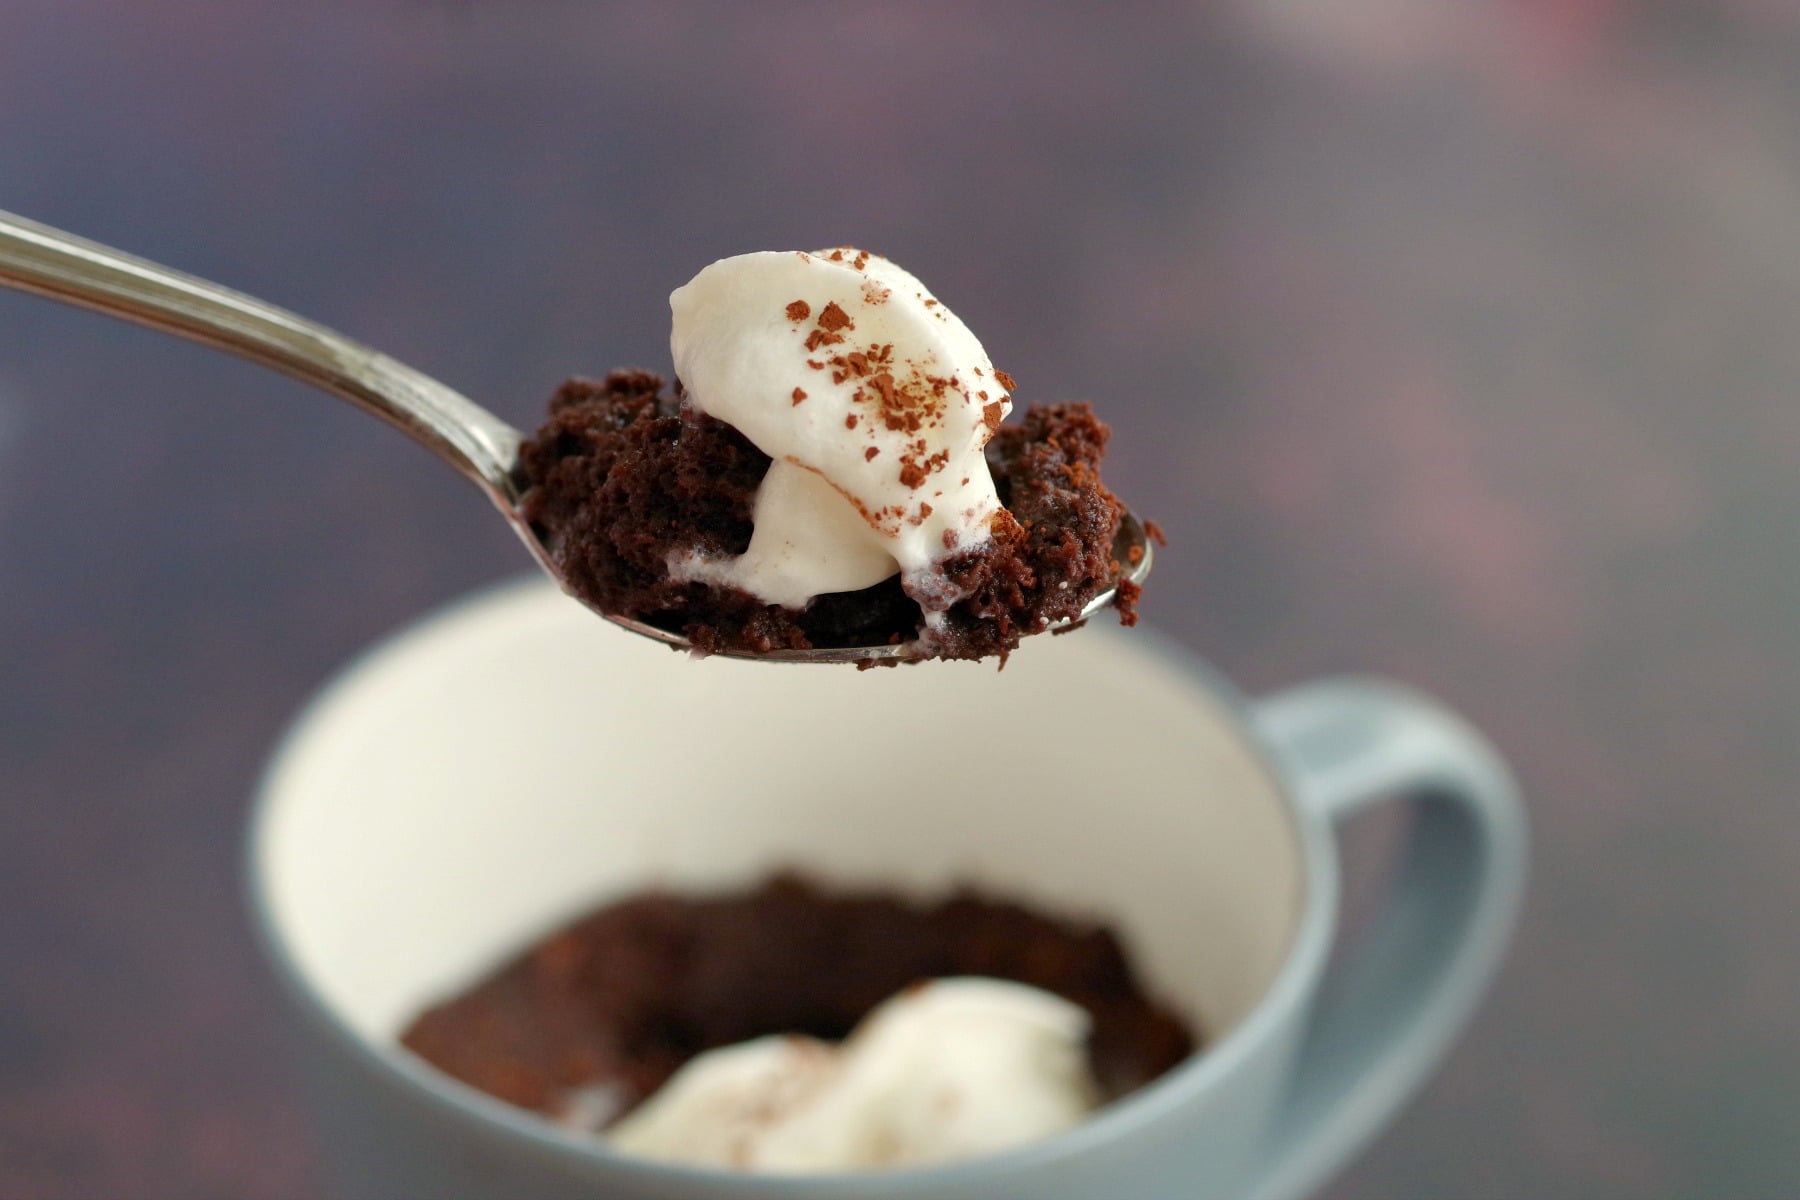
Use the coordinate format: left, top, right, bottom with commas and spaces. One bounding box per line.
0, 212, 1152, 662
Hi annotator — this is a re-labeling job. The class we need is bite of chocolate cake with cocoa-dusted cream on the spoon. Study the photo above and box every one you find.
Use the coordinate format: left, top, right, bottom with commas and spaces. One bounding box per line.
520, 248, 1138, 658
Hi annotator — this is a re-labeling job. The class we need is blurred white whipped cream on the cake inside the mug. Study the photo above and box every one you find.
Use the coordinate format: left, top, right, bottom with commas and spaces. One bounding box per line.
608, 979, 1098, 1175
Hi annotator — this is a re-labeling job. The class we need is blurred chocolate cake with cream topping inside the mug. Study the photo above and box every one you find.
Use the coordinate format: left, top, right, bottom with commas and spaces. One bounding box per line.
403, 876, 1193, 1173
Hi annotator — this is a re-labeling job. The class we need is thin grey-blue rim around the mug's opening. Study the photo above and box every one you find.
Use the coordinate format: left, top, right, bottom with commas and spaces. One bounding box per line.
243, 574, 1337, 1200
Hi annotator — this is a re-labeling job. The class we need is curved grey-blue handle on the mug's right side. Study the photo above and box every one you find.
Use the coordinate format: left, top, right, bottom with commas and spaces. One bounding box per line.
1249, 678, 1526, 1200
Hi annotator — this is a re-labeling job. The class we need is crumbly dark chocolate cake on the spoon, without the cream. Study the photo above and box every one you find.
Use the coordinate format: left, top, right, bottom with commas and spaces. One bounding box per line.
520, 371, 1138, 658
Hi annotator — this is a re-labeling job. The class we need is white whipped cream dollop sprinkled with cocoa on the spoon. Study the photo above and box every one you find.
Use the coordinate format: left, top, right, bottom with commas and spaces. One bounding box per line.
670, 246, 1012, 624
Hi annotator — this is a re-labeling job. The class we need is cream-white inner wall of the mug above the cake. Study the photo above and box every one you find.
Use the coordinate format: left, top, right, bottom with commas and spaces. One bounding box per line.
252, 581, 1303, 1065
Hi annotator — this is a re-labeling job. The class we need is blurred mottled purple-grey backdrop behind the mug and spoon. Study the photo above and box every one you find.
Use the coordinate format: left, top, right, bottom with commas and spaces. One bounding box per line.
0, 0, 1800, 1200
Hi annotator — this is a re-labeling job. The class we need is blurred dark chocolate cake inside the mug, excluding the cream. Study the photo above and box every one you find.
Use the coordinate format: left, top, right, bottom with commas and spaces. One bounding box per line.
401, 874, 1195, 1119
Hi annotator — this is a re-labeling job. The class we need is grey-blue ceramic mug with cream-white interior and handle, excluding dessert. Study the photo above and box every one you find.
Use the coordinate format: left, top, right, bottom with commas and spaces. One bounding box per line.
250, 581, 1525, 1200
